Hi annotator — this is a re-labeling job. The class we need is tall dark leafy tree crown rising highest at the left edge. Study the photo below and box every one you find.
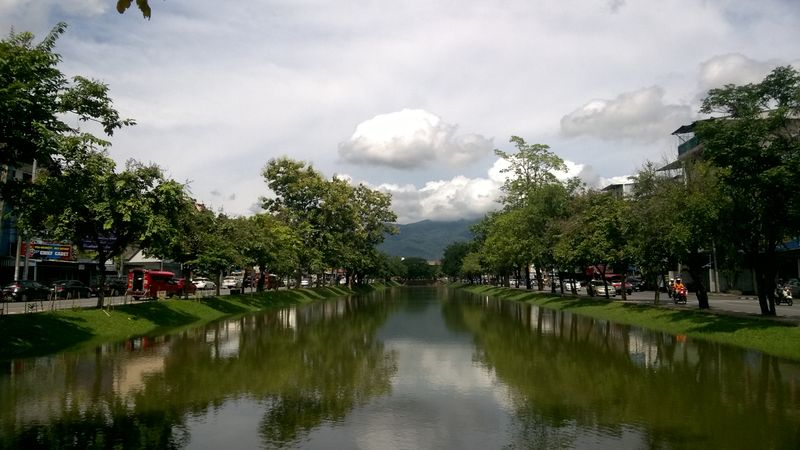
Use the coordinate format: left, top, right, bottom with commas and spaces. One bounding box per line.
0, 22, 134, 202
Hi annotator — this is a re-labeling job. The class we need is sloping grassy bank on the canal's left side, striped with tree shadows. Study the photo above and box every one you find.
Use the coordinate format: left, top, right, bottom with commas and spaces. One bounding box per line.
0, 284, 384, 360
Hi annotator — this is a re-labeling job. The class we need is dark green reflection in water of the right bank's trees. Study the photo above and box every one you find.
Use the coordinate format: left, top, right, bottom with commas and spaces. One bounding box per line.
443, 297, 800, 448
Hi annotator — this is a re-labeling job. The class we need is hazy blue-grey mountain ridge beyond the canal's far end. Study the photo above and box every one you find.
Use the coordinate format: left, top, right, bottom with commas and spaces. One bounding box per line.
378, 219, 477, 260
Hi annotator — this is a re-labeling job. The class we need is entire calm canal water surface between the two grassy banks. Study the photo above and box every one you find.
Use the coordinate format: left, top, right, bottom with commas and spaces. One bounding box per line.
0, 288, 800, 449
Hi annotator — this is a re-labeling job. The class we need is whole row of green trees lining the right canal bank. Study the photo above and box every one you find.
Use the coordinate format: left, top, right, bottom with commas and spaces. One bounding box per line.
442, 67, 800, 315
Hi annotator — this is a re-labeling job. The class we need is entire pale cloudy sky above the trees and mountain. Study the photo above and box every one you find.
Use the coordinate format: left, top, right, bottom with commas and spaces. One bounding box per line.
0, 0, 800, 223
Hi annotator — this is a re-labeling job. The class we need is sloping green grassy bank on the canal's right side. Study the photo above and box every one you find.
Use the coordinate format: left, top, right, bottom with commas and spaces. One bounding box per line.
464, 286, 800, 361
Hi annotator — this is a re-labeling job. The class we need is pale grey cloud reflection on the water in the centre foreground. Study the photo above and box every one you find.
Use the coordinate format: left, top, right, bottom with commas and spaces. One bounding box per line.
346, 339, 511, 448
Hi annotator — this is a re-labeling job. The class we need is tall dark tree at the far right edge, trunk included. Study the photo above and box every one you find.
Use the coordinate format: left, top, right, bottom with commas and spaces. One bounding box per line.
695, 66, 800, 315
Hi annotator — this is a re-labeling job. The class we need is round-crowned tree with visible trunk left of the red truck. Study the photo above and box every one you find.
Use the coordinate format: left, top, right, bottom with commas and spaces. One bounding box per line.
16, 149, 185, 308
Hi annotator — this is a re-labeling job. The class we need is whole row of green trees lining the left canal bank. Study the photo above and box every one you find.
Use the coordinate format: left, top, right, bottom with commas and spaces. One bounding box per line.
0, 23, 397, 307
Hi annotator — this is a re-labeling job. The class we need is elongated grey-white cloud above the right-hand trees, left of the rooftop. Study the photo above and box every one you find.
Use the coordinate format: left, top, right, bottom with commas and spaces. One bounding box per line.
561, 86, 692, 141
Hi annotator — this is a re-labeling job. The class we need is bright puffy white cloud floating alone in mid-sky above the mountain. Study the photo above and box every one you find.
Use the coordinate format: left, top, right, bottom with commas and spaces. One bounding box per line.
339, 109, 492, 169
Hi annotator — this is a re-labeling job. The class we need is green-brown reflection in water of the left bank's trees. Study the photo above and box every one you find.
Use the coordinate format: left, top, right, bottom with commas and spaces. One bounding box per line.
0, 298, 396, 448
